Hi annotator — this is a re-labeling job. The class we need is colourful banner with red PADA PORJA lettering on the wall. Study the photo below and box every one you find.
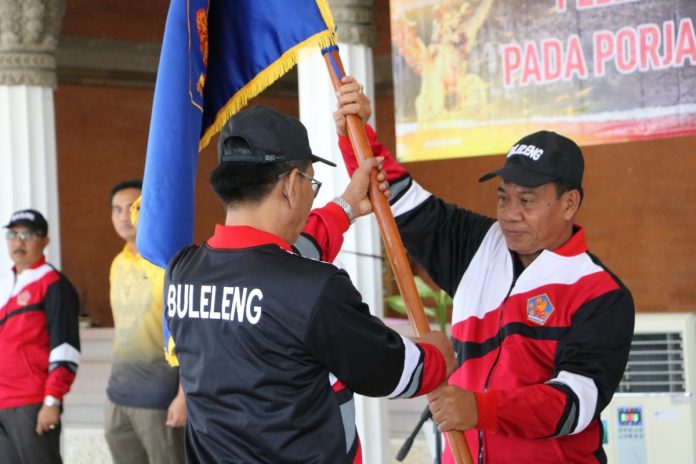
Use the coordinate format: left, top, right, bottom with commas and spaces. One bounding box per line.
391, 0, 696, 161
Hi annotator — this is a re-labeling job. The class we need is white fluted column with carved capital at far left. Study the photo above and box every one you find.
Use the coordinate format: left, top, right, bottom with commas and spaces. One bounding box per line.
0, 0, 65, 268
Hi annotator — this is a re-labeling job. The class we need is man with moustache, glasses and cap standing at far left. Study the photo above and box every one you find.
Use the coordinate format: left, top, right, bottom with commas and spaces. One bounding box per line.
0, 209, 80, 464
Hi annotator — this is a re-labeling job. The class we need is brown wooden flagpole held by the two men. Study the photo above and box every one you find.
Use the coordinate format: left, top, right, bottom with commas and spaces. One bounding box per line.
322, 45, 473, 464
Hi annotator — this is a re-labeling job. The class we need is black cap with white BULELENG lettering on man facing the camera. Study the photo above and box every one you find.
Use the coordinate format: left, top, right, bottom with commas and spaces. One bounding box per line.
479, 131, 585, 191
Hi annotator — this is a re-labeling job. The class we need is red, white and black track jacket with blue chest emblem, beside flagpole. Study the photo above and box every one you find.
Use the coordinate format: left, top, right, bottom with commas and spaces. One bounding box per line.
341, 128, 634, 464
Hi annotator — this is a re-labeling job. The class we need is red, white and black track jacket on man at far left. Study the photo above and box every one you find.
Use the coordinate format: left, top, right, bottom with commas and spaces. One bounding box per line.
0, 257, 80, 408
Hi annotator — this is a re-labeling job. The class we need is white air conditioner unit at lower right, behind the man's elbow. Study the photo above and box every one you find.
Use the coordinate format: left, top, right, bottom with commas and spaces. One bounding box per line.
602, 313, 696, 464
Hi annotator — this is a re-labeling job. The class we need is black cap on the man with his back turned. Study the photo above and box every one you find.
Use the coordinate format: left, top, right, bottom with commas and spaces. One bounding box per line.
218, 106, 336, 167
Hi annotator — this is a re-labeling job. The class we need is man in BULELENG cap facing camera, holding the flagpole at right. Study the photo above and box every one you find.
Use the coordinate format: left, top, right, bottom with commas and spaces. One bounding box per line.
334, 78, 634, 464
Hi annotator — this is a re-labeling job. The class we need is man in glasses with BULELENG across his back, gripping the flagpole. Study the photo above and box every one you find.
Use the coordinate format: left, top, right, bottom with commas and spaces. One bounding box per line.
164, 107, 454, 463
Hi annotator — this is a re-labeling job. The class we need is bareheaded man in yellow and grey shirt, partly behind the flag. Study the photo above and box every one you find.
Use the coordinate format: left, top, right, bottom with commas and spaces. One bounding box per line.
104, 180, 186, 464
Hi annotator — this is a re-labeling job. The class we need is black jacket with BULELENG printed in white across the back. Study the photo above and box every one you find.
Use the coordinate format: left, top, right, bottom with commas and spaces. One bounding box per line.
164, 223, 445, 463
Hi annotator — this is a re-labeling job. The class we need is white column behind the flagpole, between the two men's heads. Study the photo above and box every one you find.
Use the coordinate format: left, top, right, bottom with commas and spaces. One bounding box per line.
298, 0, 391, 464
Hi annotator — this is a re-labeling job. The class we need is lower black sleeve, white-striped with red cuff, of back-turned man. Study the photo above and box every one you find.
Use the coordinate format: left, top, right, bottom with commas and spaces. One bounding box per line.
304, 271, 445, 397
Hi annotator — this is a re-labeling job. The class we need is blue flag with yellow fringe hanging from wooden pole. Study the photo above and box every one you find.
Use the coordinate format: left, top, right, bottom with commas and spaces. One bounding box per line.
136, 0, 335, 362
